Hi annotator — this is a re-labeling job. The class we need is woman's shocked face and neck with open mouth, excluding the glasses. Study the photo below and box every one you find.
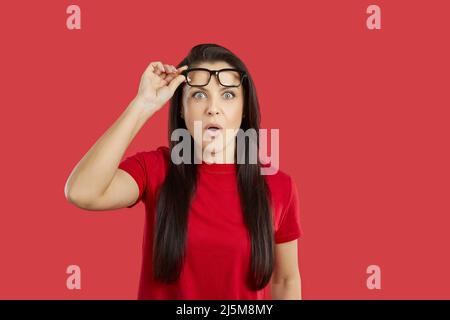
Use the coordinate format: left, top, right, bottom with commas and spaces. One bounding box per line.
181, 62, 244, 163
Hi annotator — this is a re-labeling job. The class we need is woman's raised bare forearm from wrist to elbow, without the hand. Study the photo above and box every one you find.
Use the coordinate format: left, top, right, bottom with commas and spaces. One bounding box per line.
64, 100, 152, 203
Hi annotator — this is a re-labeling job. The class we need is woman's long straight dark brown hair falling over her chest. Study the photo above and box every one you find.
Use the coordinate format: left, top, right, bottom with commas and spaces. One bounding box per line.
153, 43, 274, 290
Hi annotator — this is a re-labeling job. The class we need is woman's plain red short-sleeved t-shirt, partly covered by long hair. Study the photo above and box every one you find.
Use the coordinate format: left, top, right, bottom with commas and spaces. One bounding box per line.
119, 147, 303, 300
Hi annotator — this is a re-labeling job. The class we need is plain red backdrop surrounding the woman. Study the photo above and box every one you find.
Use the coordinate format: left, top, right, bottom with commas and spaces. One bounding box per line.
0, 0, 450, 299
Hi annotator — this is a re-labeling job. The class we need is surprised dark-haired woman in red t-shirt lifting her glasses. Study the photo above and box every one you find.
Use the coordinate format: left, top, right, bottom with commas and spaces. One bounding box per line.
65, 44, 302, 299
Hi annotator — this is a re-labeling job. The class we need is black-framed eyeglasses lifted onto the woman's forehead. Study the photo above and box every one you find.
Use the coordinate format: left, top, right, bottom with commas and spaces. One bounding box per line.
181, 68, 247, 87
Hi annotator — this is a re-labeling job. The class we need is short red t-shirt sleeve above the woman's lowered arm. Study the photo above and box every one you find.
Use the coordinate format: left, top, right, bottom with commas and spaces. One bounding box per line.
275, 177, 303, 243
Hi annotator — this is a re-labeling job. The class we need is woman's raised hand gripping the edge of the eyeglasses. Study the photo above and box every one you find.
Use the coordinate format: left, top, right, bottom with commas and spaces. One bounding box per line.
134, 61, 188, 113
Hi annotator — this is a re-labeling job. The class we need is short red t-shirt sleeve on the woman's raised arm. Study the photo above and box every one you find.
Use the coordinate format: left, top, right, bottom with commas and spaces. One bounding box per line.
119, 152, 147, 208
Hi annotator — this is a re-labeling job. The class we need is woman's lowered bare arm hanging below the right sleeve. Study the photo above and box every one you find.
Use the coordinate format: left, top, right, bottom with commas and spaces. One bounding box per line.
271, 239, 302, 300
